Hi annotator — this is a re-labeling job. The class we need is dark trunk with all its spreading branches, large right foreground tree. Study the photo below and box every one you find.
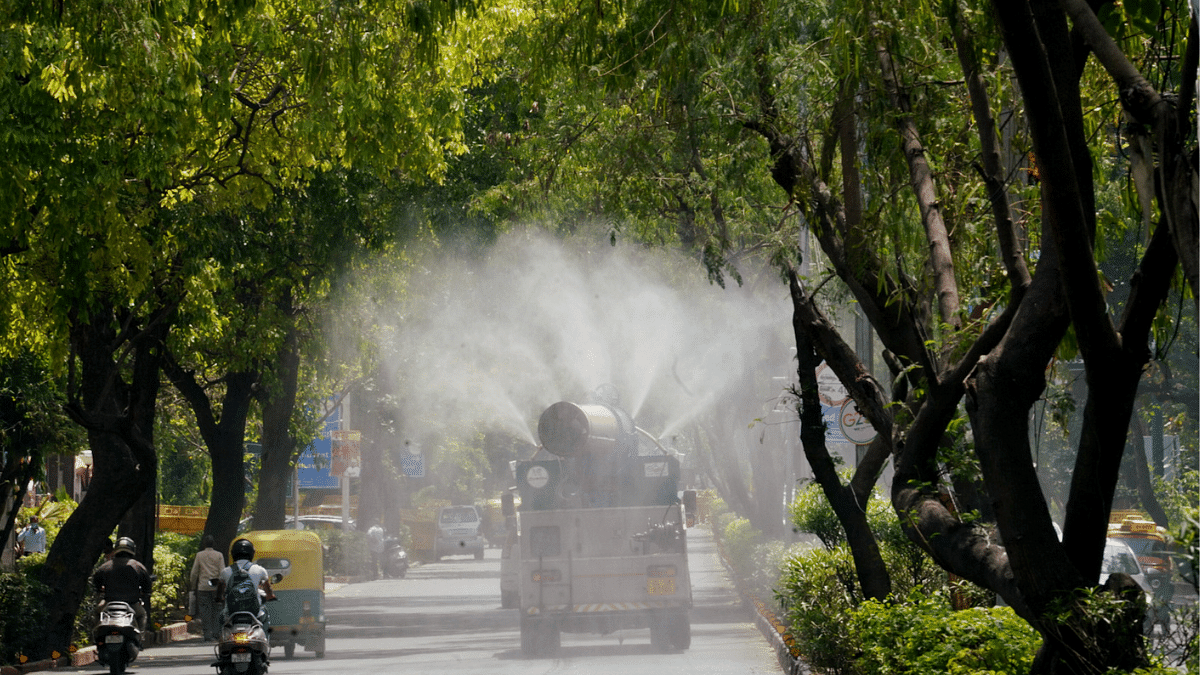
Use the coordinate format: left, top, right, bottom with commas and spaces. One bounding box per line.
785, 5, 1194, 673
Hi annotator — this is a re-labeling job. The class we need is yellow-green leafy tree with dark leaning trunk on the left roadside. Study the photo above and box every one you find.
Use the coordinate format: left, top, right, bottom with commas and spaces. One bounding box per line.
0, 1, 525, 650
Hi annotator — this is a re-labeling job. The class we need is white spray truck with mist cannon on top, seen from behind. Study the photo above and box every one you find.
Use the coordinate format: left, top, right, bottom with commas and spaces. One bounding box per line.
504, 393, 692, 656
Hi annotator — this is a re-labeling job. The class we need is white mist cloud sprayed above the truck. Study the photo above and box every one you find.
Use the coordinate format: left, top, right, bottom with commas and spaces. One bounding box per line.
380, 228, 794, 443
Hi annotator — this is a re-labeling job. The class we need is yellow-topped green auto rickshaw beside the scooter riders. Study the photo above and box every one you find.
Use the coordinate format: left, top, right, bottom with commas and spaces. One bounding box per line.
242, 530, 325, 658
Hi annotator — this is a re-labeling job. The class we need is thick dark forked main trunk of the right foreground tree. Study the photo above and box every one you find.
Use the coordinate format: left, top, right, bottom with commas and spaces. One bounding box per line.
967, 2, 1176, 673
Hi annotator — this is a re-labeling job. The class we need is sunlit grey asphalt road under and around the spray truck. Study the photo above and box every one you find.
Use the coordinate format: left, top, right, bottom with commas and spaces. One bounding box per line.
70, 528, 781, 675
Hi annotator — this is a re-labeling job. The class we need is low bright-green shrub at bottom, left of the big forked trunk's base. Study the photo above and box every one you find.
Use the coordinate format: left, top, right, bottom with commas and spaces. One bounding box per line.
847, 592, 1042, 675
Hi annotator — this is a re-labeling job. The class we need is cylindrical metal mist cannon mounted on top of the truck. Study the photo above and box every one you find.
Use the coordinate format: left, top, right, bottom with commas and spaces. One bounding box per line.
538, 401, 637, 458
